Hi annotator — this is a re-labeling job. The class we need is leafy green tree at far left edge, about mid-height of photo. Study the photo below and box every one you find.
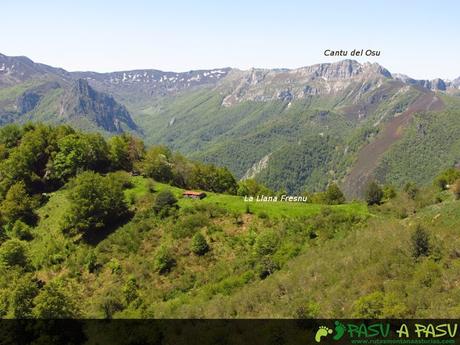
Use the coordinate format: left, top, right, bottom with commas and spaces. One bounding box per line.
0, 182, 35, 224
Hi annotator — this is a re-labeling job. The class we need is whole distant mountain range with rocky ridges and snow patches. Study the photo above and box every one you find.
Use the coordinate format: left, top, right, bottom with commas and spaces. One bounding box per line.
0, 54, 460, 197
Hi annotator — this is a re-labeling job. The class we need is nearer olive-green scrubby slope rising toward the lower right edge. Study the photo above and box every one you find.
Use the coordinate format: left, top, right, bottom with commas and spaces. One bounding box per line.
157, 194, 460, 318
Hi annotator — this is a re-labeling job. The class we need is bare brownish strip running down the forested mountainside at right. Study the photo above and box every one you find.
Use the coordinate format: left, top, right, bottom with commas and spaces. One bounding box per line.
343, 92, 444, 197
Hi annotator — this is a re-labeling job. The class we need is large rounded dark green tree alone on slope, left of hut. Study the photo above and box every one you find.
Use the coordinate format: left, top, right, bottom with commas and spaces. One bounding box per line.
64, 171, 128, 232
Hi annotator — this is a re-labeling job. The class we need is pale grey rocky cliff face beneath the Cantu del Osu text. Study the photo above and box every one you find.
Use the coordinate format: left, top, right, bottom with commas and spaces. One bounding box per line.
221, 60, 392, 106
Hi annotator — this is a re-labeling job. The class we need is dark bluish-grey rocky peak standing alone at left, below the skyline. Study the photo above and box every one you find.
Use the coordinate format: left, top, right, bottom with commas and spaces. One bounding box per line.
61, 79, 137, 132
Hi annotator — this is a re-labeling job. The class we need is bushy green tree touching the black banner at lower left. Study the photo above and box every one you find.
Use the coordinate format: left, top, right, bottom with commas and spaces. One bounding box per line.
32, 281, 80, 319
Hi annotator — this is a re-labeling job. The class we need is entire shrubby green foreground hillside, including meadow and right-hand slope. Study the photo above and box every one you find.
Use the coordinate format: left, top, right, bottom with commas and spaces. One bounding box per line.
23, 177, 460, 317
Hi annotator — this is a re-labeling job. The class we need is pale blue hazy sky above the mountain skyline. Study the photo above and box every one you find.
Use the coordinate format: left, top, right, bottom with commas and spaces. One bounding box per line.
0, 0, 460, 78
